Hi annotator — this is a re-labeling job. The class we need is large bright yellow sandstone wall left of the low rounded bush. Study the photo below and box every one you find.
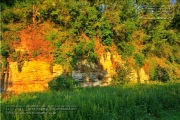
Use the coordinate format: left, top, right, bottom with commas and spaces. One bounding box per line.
8, 60, 63, 93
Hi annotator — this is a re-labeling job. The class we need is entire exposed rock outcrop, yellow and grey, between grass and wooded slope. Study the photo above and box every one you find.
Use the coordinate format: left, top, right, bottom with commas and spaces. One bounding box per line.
8, 52, 149, 93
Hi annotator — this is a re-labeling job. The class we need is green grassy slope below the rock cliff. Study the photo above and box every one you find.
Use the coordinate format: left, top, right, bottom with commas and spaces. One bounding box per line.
1, 83, 180, 120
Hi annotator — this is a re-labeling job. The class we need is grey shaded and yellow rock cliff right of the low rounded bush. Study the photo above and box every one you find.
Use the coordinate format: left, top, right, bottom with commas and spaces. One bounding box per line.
72, 52, 149, 87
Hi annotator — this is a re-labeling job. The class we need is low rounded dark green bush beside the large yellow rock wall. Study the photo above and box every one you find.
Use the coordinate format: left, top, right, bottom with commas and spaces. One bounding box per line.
48, 75, 77, 91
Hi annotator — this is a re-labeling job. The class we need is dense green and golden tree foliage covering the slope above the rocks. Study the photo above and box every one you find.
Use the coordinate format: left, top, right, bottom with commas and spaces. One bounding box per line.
1, 0, 180, 81
